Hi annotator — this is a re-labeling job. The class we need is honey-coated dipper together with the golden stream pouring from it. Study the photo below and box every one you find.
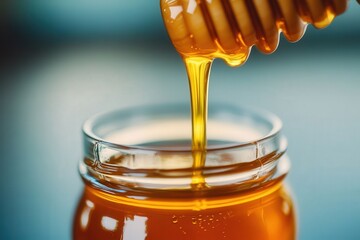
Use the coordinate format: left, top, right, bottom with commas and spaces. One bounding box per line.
161, 0, 347, 190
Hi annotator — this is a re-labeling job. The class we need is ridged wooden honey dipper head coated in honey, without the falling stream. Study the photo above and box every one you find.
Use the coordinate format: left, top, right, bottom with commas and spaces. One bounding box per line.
161, 0, 347, 65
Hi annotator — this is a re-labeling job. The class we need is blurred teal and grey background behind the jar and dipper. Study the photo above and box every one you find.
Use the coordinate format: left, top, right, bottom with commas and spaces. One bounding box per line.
0, 0, 360, 240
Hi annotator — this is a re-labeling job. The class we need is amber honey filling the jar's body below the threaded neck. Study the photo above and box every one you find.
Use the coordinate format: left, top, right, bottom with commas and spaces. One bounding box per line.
74, 181, 296, 240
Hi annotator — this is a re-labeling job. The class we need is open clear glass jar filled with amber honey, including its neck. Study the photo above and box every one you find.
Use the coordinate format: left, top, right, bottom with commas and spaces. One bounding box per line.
73, 105, 296, 240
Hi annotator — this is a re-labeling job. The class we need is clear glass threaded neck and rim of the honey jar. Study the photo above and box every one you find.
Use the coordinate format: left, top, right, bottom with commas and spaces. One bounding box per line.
80, 105, 289, 199
